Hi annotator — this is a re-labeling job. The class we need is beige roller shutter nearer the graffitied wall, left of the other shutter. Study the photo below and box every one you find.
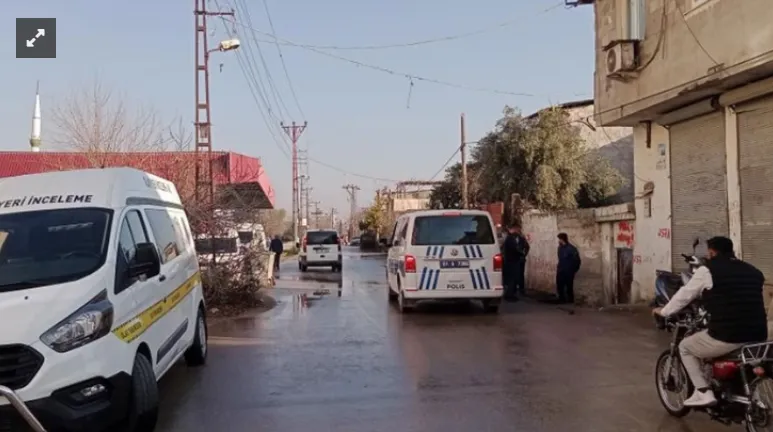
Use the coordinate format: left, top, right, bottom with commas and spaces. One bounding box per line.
669, 112, 729, 271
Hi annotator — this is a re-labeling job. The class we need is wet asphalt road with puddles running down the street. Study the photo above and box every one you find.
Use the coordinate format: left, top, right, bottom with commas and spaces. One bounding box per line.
159, 249, 724, 432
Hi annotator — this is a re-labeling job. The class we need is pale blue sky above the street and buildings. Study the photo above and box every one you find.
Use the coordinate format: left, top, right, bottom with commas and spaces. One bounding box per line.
0, 0, 594, 212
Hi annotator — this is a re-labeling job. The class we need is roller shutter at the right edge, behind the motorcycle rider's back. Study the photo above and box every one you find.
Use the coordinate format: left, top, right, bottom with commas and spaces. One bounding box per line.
736, 97, 773, 283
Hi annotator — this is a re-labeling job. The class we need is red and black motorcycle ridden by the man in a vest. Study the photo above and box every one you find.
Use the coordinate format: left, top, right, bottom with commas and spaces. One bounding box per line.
653, 240, 773, 432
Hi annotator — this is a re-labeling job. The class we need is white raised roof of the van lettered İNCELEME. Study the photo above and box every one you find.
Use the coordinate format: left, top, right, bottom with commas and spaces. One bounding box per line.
0, 168, 182, 214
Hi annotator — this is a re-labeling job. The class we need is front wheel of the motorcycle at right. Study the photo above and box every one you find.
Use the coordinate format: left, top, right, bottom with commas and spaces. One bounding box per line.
655, 350, 692, 417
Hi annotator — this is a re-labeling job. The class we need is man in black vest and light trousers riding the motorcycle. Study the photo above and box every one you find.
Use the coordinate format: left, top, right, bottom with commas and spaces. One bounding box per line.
653, 237, 768, 407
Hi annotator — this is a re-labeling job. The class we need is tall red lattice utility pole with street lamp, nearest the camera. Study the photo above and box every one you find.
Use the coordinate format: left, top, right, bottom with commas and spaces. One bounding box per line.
193, 0, 232, 207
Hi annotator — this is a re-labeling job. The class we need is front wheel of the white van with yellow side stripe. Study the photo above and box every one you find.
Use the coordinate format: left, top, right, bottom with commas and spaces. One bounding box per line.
123, 354, 158, 432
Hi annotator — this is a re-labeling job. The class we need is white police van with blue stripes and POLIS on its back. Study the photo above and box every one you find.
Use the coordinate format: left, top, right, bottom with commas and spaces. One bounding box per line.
387, 210, 503, 313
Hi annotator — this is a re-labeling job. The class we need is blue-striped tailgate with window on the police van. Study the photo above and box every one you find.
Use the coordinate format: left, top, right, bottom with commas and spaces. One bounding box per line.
411, 211, 501, 291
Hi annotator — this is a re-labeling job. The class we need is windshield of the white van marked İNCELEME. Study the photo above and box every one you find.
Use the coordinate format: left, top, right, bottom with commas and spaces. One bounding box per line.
0, 208, 113, 292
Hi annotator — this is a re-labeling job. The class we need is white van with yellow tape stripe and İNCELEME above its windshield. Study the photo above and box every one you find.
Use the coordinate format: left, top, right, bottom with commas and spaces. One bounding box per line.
0, 168, 207, 432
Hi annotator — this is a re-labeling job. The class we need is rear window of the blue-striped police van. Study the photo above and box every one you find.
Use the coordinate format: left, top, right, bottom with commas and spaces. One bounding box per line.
411, 215, 495, 246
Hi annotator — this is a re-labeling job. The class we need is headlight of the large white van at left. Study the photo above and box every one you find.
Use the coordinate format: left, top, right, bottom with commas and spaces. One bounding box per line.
40, 290, 113, 353
